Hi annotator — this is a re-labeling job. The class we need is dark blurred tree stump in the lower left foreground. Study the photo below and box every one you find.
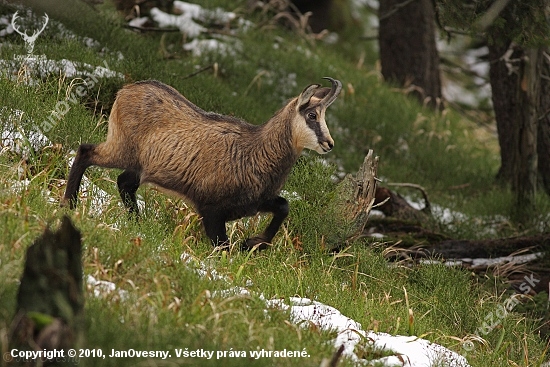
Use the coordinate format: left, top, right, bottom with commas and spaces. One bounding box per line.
9, 216, 84, 366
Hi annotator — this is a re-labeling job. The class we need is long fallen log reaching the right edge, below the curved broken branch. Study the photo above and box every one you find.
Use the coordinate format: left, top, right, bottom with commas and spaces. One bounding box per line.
369, 224, 550, 293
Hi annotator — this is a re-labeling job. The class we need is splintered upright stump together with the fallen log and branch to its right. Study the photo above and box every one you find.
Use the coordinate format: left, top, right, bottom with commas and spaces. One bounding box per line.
333, 155, 550, 292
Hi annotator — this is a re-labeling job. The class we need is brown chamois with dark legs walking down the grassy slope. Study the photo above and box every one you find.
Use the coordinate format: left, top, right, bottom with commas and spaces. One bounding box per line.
61, 78, 342, 249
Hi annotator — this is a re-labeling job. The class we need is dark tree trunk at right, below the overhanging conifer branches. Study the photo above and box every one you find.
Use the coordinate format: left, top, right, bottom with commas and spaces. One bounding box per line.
489, 42, 550, 221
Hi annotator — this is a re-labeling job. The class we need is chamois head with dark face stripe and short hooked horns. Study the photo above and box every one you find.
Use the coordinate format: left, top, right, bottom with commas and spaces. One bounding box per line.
293, 77, 342, 154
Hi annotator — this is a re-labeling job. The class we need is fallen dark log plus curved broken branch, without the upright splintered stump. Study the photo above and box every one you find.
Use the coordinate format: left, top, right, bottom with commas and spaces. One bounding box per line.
365, 184, 550, 292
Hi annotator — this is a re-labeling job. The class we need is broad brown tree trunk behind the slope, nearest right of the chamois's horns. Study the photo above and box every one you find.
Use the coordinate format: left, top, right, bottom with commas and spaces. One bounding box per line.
378, 0, 442, 108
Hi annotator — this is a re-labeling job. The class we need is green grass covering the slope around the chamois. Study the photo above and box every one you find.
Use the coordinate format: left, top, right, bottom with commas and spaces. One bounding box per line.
0, 1, 548, 366
